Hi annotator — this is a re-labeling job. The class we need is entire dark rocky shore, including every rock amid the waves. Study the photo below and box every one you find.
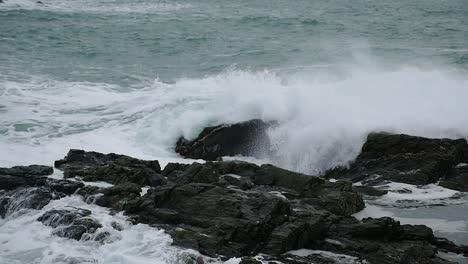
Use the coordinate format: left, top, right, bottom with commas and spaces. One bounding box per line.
0, 120, 468, 263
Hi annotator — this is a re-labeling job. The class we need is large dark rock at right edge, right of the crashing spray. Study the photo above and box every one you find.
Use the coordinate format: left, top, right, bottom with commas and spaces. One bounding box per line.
326, 133, 468, 185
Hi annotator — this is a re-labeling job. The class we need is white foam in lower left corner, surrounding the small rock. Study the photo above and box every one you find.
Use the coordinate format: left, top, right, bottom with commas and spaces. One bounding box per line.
0, 196, 235, 264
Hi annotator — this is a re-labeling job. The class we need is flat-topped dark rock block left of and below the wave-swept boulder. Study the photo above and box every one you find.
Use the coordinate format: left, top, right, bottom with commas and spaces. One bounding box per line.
55, 149, 161, 186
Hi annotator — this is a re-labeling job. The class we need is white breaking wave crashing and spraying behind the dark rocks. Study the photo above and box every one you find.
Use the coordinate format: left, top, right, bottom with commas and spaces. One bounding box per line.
0, 65, 468, 174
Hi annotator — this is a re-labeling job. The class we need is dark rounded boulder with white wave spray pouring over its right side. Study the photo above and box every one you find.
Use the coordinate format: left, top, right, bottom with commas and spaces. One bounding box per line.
175, 119, 272, 160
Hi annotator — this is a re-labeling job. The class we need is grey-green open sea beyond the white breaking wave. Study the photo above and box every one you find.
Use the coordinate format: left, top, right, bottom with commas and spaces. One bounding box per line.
0, 0, 468, 85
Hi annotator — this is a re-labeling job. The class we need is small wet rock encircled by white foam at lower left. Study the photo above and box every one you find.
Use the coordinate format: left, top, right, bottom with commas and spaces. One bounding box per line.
37, 208, 102, 240
